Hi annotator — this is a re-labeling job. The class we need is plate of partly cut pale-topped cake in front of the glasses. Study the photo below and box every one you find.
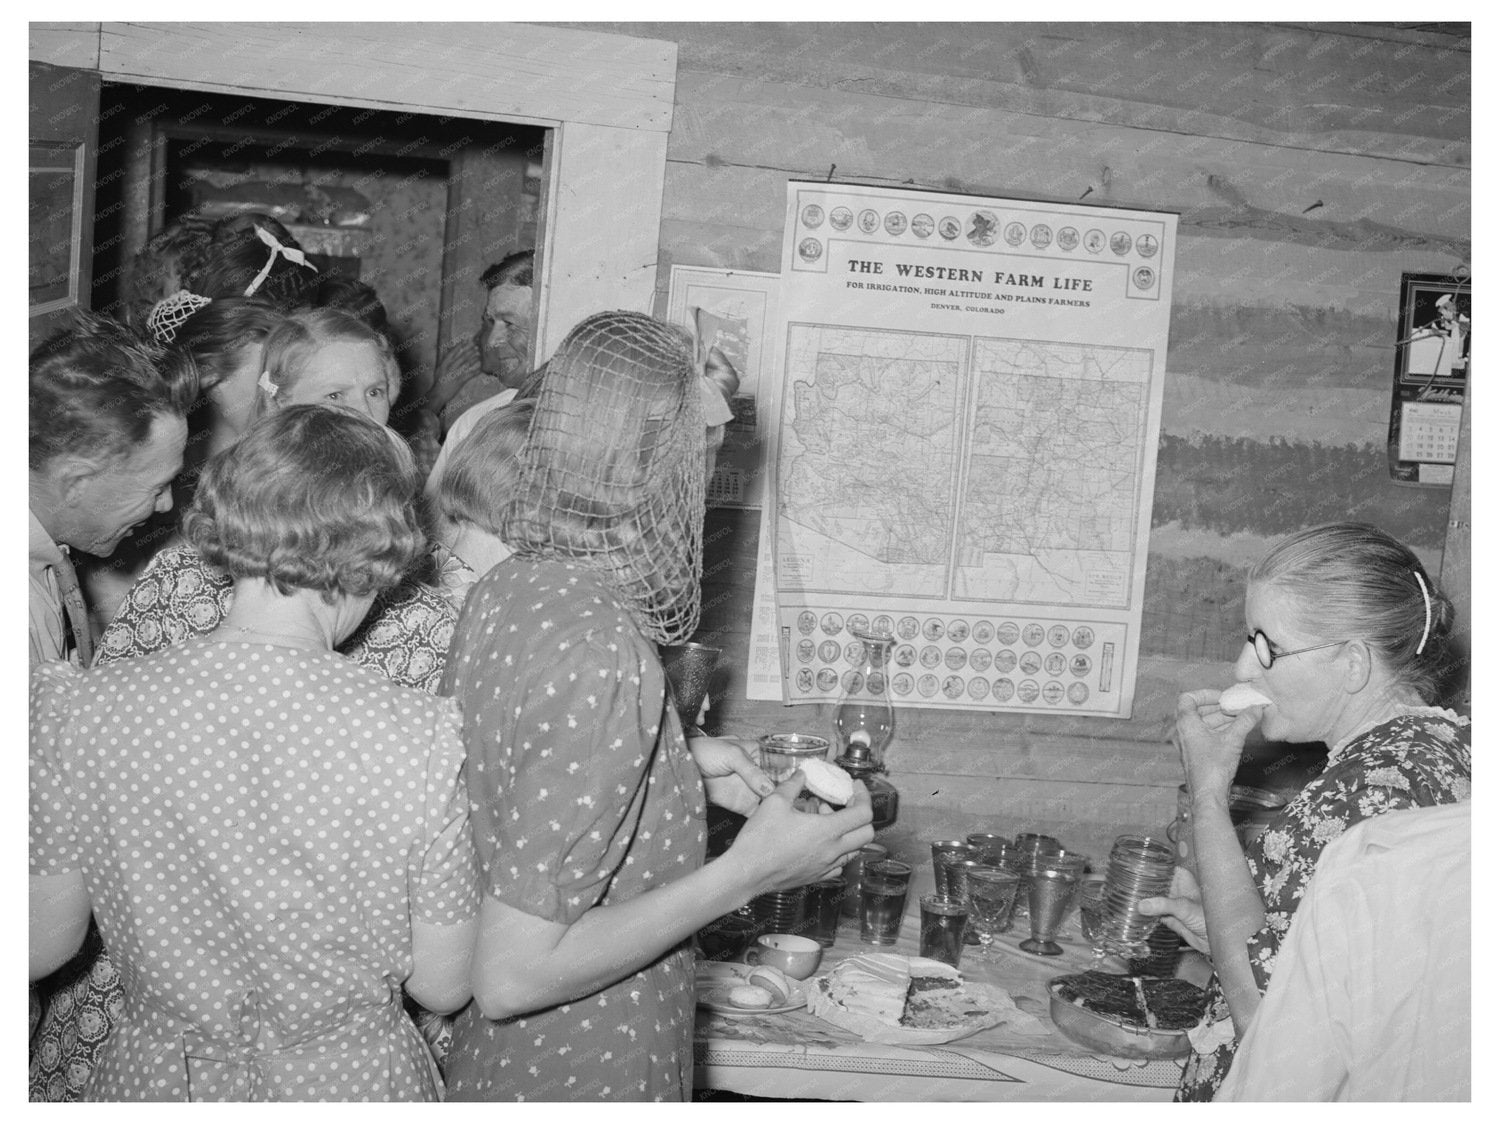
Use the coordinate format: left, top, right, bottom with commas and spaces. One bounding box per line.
807, 953, 1047, 1046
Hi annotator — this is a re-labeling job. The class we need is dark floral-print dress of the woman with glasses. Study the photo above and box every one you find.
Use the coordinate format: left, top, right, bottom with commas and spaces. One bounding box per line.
1178, 707, 1472, 1100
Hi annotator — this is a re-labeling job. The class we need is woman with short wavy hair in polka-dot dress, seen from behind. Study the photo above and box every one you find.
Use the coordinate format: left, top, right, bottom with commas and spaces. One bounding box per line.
30, 407, 477, 1100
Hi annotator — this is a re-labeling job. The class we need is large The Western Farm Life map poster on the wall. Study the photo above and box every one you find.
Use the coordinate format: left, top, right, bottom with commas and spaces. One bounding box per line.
752, 182, 1176, 717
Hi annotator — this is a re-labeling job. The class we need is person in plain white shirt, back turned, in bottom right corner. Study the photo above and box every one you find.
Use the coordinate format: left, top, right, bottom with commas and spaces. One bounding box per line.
1215, 801, 1472, 1101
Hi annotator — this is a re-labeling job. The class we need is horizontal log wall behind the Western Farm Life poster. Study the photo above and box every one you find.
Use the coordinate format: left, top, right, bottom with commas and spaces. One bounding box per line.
561, 24, 1472, 848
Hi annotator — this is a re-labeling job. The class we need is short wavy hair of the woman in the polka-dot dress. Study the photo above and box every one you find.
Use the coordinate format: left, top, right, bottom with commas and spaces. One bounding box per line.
183, 405, 425, 602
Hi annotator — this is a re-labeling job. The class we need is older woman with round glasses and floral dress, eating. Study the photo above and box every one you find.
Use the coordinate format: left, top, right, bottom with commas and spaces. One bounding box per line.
1142, 522, 1472, 1100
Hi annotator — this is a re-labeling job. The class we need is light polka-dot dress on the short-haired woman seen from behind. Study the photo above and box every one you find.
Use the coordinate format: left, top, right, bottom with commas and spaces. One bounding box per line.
32, 639, 479, 1100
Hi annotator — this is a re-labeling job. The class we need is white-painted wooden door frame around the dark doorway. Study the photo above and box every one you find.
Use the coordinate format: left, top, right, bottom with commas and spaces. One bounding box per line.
29, 23, 677, 359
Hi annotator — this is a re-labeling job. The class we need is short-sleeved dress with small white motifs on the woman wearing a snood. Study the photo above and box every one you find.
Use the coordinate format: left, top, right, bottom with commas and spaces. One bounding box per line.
444, 558, 707, 1101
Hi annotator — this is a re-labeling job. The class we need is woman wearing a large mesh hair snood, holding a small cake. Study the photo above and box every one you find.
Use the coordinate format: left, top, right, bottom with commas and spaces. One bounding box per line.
444, 312, 873, 1101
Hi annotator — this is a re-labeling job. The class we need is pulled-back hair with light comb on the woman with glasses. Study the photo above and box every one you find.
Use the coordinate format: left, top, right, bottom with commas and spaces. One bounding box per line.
1250, 522, 1454, 702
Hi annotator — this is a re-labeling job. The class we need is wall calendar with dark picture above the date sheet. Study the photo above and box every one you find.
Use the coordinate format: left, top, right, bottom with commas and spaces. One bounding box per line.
1388, 270, 1473, 488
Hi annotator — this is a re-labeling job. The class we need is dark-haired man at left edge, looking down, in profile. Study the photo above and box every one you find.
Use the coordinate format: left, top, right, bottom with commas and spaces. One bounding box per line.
27, 315, 197, 666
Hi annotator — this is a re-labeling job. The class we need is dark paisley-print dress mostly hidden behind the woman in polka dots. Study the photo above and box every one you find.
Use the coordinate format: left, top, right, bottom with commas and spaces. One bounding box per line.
29, 546, 458, 1101
